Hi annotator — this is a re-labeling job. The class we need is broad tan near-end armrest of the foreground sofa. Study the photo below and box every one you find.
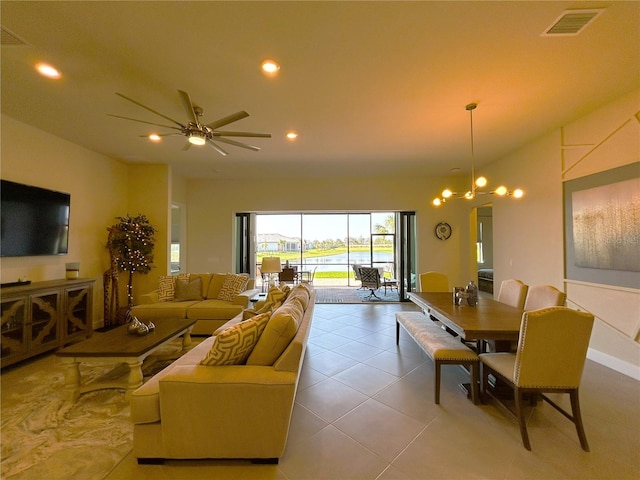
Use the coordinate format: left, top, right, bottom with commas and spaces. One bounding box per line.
159, 365, 296, 458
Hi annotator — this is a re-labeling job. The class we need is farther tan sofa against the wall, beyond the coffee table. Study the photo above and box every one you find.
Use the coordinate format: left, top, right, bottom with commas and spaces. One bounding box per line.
131, 273, 260, 335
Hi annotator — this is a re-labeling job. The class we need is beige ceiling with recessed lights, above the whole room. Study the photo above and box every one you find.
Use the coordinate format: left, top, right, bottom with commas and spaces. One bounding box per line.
0, 0, 640, 179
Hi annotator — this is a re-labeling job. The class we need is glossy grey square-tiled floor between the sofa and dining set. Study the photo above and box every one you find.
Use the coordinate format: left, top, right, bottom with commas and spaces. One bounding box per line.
107, 304, 640, 480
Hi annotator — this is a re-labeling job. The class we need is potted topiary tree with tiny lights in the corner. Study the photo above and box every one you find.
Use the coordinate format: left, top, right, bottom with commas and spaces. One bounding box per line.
105, 214, 156, 323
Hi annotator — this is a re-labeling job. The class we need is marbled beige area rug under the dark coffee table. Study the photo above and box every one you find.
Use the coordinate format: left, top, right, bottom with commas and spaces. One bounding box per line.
0, 339, 199, 480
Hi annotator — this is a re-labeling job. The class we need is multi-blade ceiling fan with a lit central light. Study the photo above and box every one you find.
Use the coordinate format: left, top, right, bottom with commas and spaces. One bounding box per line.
107, 90, 271, 155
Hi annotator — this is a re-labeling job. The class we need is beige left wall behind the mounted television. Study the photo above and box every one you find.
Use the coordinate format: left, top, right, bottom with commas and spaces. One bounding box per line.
0, 115, 128, 324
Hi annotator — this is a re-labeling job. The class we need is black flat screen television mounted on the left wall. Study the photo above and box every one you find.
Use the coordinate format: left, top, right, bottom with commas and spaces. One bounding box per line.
0, 180, 71, 257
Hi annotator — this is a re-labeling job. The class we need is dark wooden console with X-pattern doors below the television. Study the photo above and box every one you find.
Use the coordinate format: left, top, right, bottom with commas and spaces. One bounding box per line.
0, 278, 95, 367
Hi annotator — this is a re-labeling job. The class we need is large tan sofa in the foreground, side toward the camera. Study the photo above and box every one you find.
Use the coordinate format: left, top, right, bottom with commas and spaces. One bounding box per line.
131, 285, 316, 463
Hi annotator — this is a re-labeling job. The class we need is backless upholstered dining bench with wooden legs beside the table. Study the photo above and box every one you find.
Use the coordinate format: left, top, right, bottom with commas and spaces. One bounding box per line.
396, 312, 480, 405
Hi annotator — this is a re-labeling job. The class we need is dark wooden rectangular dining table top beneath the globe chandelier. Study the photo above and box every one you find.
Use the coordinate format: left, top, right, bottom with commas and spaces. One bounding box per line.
408, 292, 524, 340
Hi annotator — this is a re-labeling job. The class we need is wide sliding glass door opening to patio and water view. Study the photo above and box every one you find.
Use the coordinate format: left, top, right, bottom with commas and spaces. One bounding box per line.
236, 212, 415, 299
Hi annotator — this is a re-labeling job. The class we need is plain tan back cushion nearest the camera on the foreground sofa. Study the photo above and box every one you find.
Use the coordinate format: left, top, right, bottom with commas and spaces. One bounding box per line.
243, 300, 304, 365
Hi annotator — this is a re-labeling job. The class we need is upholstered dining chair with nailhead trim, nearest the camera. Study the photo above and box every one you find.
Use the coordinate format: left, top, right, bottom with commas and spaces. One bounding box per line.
480, 307, 593, 452
